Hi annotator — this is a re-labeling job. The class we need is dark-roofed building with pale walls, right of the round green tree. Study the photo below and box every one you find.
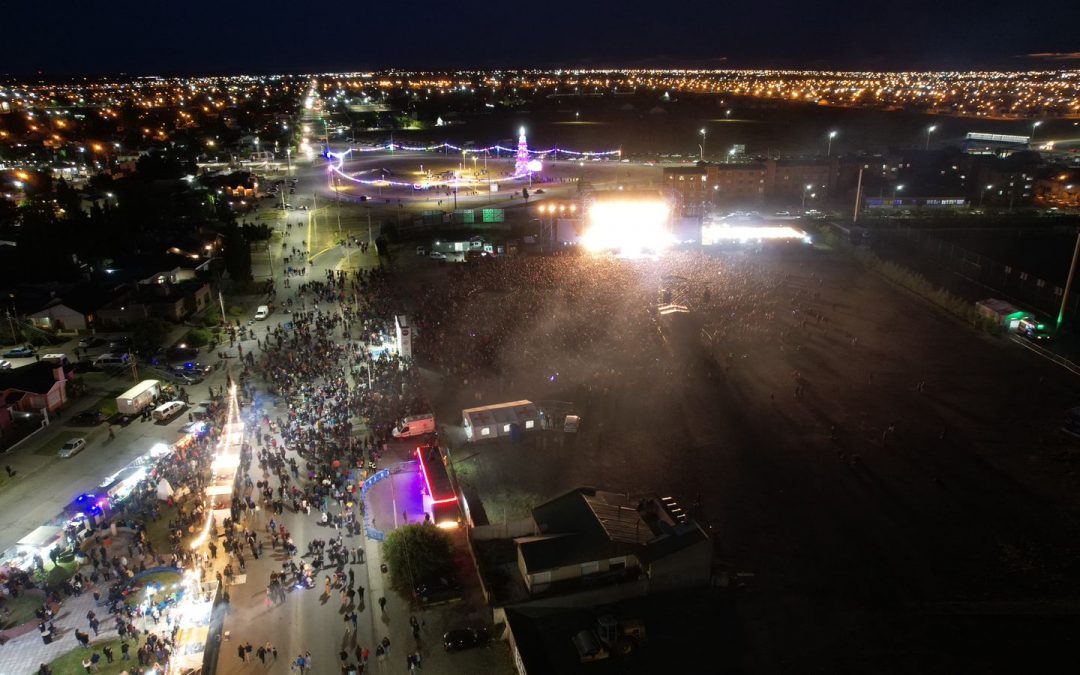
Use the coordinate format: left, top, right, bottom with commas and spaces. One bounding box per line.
514, 487, 713, 596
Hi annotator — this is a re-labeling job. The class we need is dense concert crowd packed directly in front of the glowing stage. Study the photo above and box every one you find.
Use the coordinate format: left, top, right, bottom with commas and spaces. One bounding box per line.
414, 252, 784, 397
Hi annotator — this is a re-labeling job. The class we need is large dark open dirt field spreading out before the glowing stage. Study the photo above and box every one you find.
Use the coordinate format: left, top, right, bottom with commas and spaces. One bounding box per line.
393, 247, 1080, 672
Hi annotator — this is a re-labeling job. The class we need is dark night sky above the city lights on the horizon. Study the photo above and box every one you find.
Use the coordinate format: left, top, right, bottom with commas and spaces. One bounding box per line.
8, 0, 1080, 76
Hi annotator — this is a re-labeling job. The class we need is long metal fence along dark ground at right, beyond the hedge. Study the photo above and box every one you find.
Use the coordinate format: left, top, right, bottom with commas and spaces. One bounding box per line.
873, 226, 1080, 321
